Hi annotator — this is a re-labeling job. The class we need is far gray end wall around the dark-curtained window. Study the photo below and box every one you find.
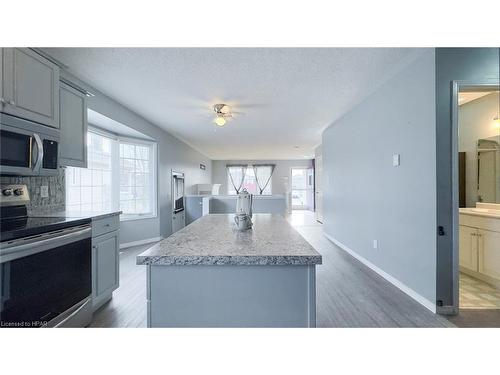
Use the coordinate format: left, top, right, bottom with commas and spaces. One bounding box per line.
212, 159, 312, 195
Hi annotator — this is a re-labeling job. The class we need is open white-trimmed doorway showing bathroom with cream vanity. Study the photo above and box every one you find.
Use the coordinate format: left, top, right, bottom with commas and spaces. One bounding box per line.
452, 81, 500, 327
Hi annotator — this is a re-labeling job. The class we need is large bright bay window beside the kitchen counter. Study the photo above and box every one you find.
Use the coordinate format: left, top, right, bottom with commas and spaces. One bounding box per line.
66, 130, 156, 220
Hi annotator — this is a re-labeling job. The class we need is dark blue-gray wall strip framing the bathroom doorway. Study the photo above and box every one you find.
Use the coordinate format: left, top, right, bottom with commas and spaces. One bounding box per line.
435, 48, 500, 306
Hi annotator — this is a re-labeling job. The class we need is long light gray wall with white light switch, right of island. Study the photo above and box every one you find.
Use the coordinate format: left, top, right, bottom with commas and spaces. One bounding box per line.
322, 49, 436, 303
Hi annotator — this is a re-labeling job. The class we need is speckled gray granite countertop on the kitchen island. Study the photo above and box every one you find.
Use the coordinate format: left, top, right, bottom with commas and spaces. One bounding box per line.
137, 214, 322, 266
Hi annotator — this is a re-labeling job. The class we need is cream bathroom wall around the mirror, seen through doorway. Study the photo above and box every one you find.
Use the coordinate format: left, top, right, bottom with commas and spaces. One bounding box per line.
458, 93, 500, 207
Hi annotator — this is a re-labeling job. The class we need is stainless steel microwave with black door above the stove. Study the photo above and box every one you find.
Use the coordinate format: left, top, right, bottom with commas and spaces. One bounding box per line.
0, 113, 59, 176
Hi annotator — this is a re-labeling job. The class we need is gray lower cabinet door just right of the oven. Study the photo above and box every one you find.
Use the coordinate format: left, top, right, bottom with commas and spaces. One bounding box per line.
92, 232, 120, 298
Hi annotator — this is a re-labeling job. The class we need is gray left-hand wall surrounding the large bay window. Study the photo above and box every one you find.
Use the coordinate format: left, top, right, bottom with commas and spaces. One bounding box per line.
60, 74, 212, 243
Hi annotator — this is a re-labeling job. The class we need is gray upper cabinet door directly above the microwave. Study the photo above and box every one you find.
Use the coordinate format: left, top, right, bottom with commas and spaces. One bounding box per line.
2, 48, 59, 128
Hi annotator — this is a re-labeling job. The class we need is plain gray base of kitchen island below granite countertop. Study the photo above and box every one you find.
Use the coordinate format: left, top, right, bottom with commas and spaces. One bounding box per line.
147, 265, 316, 327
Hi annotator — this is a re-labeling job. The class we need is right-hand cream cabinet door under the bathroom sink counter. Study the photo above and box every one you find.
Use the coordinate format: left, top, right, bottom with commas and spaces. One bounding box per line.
478, 229, 500, 279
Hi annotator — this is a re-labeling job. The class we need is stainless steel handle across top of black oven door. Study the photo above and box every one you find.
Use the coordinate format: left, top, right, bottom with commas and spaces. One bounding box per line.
0, 225, 92, 263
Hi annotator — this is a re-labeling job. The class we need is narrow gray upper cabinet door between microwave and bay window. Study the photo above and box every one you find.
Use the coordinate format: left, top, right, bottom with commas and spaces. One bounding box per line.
59, 82, 87, 168
